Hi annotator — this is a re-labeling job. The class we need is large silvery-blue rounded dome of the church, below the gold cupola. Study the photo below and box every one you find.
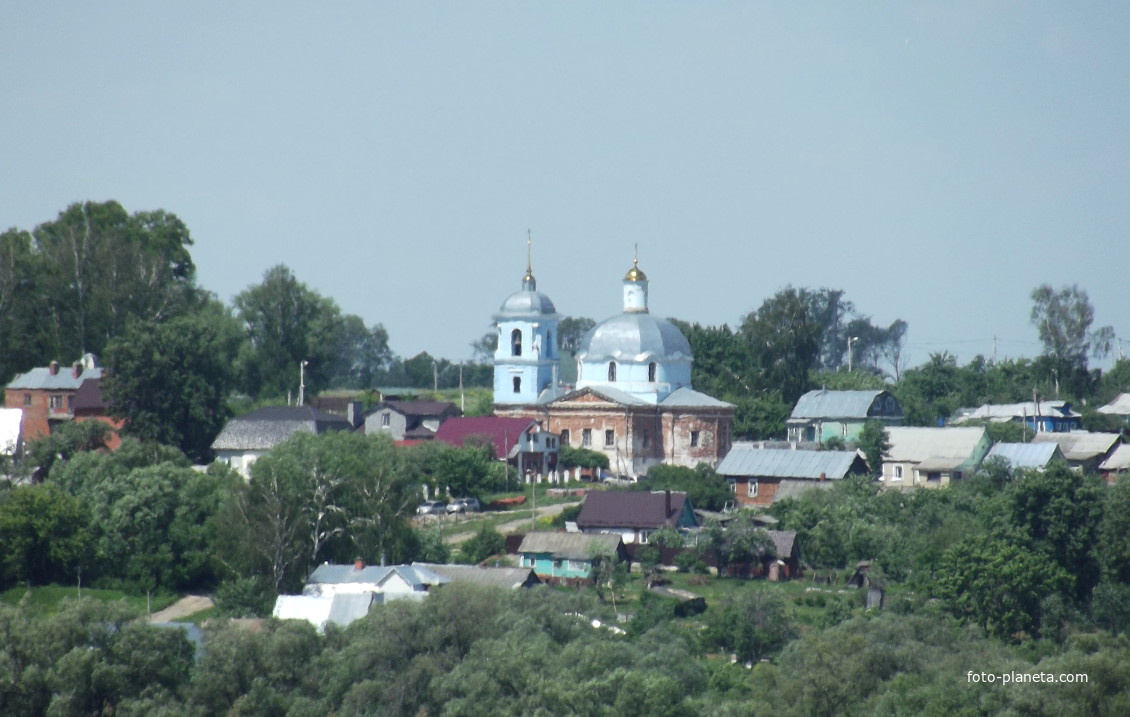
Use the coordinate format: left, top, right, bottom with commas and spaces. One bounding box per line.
576, 312, 692, 361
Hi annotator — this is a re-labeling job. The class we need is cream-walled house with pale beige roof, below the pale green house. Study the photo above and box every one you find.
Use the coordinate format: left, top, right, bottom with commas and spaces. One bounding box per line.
879, 427, 992, 490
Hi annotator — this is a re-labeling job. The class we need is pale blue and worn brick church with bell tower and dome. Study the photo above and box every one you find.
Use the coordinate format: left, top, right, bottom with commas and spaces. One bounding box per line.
494, 249, 733, 476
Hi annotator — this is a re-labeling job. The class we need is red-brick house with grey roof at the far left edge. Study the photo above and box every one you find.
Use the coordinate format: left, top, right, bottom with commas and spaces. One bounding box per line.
5, 353, 102, 444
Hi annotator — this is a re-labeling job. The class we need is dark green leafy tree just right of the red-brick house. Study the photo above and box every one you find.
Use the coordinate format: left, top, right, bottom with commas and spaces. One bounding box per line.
103, 304, 241, 462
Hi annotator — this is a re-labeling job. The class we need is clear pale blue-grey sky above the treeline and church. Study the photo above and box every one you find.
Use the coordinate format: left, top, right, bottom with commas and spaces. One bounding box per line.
0, 0, 1130, 374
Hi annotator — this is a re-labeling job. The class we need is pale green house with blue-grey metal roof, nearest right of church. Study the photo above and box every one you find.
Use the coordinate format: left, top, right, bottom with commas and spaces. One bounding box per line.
788, 388, 905, 443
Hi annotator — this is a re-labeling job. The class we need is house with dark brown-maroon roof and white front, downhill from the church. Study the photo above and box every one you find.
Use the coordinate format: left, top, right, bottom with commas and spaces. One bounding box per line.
576, 490, 698, 543
